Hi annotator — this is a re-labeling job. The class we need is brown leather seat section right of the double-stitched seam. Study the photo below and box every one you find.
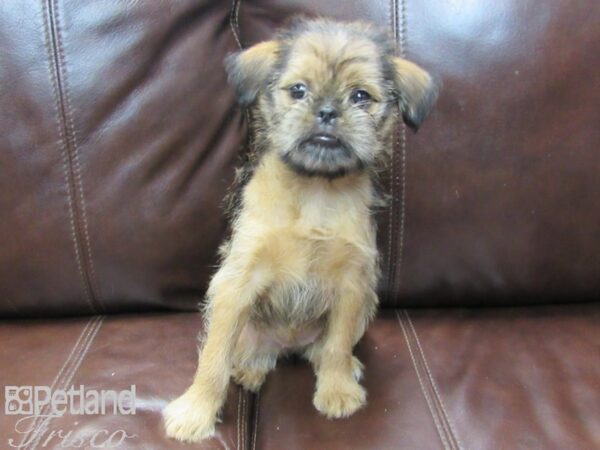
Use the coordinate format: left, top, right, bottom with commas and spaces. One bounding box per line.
400, 304, 600, 450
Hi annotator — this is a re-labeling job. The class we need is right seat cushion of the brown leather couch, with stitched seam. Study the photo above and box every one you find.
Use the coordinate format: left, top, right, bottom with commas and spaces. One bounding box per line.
251, 304, 600, 450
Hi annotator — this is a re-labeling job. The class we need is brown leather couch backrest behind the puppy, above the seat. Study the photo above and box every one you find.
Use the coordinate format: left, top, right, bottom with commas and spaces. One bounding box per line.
0, 0, 600, 316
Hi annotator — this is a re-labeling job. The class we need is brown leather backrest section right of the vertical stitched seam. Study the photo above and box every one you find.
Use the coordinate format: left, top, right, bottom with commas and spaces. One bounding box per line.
394, 0, 600, 305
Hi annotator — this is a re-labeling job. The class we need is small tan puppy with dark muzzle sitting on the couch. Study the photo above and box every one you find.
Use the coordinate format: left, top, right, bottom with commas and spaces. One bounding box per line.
164, 19, 436, 441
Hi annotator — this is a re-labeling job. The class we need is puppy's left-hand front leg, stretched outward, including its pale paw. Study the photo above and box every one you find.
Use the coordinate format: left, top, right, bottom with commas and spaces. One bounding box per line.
163, 264, 261, 442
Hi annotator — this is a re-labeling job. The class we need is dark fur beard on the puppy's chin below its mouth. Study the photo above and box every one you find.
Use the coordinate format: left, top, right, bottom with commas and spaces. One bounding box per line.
281, 140, 366, 179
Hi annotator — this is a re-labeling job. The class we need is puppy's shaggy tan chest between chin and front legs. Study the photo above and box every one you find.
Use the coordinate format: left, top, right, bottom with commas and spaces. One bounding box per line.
244, 165, 373, 347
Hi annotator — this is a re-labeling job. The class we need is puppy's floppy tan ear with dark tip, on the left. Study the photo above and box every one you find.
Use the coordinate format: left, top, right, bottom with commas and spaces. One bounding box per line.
225, 41, 279, 106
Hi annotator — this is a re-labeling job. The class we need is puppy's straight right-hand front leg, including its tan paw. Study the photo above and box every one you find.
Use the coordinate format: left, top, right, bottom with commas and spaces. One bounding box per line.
309, 283, 368, 418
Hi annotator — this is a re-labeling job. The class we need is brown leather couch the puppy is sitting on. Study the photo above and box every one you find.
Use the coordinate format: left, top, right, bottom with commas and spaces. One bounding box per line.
0, 0, 600, 450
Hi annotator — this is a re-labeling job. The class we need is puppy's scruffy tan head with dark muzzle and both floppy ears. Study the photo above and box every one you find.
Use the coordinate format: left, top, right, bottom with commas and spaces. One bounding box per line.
226, 20, 436, 178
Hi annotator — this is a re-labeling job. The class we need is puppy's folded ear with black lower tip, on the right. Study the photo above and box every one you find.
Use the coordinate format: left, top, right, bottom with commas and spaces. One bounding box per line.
392, 56, 438, 131
